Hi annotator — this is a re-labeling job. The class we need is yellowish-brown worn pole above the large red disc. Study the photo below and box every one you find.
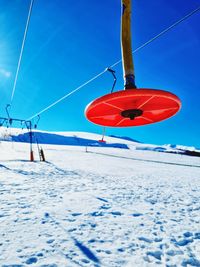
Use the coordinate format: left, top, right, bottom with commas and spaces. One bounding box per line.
121, 0, 136, 89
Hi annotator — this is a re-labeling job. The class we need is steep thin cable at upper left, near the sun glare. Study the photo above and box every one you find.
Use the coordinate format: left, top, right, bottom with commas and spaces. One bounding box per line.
10, 0, 34, 105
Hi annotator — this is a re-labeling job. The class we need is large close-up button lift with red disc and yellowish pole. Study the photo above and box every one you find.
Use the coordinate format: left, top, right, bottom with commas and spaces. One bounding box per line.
85, 0, 181, 127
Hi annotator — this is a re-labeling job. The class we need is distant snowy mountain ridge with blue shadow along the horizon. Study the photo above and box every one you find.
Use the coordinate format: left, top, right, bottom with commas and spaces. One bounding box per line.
0, 127, 200, 157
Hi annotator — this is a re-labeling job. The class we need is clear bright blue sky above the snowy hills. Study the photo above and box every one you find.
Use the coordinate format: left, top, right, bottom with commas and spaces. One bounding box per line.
0, 0, 200, 147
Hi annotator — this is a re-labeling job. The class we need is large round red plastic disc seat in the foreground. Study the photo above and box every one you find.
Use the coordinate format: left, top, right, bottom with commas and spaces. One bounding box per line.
85, 89, 181, 127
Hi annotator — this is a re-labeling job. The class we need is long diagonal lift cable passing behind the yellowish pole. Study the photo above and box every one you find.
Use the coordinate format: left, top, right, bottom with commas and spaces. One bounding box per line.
28, 6, 200, 120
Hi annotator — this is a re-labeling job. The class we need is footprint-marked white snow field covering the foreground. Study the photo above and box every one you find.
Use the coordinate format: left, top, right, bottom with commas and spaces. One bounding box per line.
0, 141, 200, 267
